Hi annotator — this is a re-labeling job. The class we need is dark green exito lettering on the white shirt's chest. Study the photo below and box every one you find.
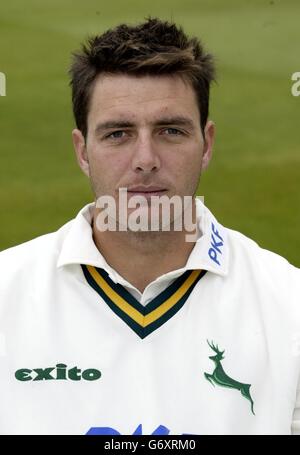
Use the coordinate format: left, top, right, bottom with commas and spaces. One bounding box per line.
15, 363, 101, 381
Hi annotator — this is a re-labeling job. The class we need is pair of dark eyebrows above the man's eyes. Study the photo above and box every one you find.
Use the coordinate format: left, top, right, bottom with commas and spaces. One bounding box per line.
95, 116, 195, 134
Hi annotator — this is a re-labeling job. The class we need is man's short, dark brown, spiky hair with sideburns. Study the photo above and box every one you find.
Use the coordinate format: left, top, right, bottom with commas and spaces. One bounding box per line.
69, 17, 215, 138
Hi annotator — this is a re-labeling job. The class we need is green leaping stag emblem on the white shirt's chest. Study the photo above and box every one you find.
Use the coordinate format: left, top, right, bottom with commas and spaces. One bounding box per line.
204, 340, 255, 415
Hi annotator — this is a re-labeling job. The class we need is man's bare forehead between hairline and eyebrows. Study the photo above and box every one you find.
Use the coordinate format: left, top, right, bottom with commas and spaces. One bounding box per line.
88, 75, 199, 123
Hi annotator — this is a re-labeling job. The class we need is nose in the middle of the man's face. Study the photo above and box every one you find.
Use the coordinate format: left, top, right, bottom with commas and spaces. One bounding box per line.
132, 134, 160, 173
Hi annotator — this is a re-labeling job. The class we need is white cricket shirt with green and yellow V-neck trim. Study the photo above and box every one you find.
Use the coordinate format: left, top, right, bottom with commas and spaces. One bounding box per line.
0, 200, 300, 435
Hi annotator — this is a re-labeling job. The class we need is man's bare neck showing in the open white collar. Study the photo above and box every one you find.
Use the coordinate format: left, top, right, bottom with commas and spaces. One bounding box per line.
93, 203, 196, 292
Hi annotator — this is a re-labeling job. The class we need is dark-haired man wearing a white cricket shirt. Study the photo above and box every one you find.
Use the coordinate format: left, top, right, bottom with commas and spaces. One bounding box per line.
0, 19, 300, 435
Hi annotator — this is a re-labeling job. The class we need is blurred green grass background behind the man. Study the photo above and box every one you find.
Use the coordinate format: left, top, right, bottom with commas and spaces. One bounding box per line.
0, 0, 300, 266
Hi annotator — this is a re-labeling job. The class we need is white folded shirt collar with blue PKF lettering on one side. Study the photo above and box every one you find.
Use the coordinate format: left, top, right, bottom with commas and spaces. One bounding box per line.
57, 197, 229, 279
